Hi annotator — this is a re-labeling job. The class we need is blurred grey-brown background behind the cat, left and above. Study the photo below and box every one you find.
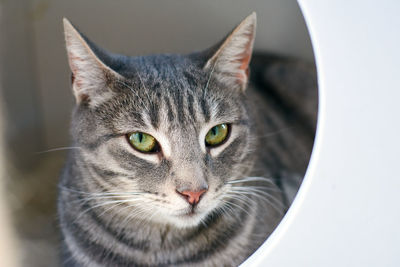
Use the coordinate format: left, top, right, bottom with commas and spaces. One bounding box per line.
0, 0, 313, 266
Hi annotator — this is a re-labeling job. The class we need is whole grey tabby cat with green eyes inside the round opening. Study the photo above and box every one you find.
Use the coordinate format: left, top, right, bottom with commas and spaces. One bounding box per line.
58, 13, 314, 266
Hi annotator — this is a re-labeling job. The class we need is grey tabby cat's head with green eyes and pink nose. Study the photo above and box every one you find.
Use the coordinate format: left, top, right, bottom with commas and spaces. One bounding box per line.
64, 13, 256, 227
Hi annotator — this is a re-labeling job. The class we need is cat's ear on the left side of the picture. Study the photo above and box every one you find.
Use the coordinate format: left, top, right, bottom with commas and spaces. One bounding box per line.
63, 18, 122, 106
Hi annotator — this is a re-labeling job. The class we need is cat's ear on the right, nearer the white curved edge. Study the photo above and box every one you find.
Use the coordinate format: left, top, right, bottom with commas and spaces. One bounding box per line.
204, 12, 257, 91
